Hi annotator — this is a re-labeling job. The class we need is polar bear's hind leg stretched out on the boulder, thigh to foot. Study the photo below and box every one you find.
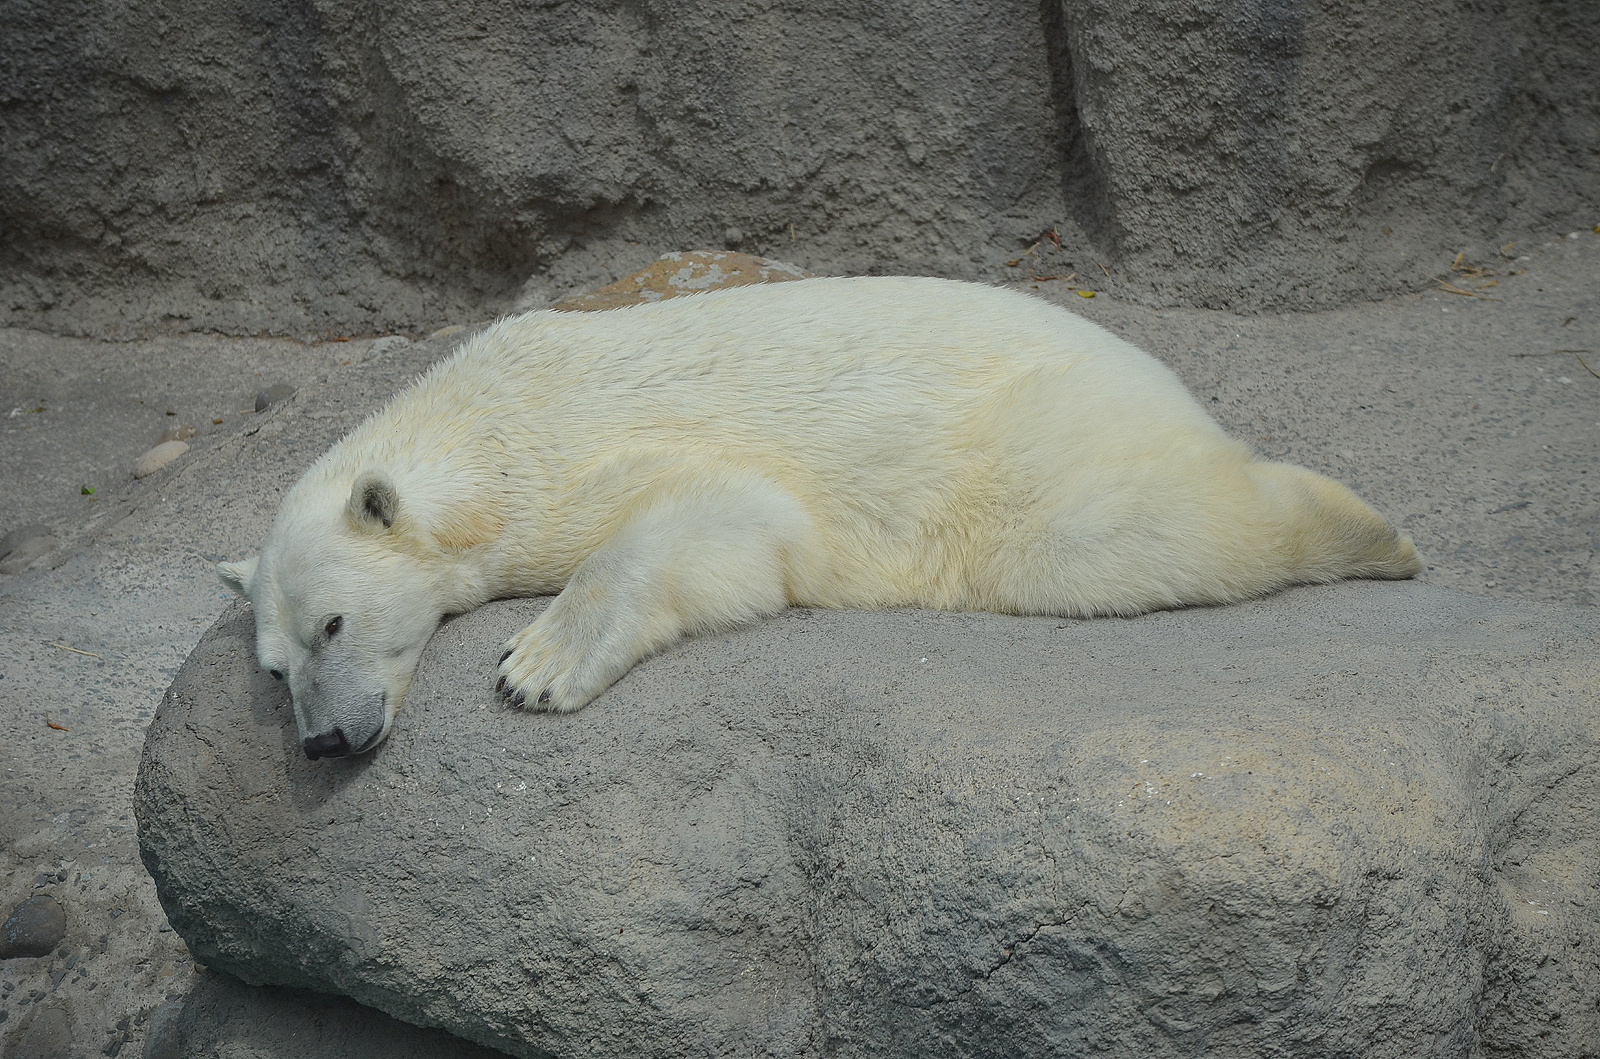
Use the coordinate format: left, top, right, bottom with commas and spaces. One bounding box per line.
965, 437, 1422, 617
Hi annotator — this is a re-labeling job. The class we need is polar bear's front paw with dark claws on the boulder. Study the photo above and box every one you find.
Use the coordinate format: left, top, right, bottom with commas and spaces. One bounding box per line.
494, 601, 637, 713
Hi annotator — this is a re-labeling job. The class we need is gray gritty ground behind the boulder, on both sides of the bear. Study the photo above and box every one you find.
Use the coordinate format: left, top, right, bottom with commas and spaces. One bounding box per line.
0, 228, 1600, 1057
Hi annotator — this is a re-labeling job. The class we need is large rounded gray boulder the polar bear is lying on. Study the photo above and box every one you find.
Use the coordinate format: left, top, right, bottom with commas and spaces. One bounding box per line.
136, 584, 1600, 1059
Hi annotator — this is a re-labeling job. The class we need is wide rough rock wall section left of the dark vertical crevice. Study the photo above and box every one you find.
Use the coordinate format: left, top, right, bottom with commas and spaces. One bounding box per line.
0, 0, 1061, 334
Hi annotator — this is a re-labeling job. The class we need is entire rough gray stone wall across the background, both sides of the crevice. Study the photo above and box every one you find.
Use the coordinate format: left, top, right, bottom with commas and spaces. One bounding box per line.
0, 0, 1600, 334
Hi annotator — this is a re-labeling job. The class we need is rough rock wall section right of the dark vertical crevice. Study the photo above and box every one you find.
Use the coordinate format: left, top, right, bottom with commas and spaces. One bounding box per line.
1045, 0, 1600, 307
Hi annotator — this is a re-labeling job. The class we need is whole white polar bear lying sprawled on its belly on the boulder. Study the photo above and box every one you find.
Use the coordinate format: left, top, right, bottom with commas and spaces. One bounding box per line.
219, 277, 1421, 758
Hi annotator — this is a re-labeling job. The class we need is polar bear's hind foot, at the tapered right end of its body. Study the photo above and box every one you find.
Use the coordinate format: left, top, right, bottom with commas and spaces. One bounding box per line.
1251, 462, 1422, 584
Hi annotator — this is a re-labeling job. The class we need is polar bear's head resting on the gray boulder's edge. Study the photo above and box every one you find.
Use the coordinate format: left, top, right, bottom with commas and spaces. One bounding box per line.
218, 472, 443, 758
